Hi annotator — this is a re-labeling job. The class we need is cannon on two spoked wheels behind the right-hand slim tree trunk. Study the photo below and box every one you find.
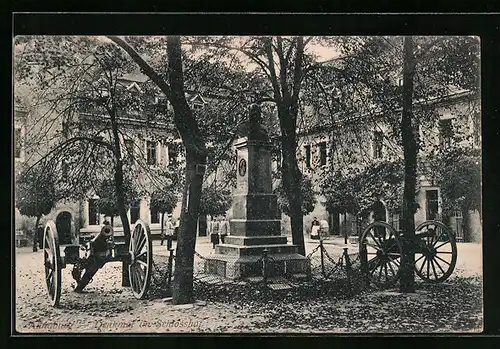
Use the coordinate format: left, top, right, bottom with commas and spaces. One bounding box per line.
359, 220, 457, 287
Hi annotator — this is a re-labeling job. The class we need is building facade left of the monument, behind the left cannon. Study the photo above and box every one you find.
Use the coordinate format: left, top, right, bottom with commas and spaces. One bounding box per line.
13, 75, 206, 234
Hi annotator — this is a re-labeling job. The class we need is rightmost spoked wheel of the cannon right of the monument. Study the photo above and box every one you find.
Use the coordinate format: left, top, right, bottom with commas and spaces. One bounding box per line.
415, 221, 457, 283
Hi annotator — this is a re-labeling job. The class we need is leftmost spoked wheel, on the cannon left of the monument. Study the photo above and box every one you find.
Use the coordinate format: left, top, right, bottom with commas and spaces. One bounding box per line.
43, 221, 62, 307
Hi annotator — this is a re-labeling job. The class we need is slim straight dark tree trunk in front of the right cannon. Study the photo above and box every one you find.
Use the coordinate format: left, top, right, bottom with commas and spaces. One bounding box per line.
399, 36, 418, 293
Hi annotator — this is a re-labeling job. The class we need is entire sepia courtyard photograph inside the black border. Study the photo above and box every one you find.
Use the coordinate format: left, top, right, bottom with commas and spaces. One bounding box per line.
11, 35, 484, 335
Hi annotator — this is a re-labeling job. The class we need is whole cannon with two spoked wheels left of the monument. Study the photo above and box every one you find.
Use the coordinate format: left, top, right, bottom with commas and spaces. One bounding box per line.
43, 211, 153, 307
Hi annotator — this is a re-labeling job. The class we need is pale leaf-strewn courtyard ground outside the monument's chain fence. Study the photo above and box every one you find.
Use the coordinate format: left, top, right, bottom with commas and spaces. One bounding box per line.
14, 239, 483, 333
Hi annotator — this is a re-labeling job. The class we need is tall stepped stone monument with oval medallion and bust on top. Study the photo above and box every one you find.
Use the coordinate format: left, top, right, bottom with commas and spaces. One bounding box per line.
205, 104, 310, 279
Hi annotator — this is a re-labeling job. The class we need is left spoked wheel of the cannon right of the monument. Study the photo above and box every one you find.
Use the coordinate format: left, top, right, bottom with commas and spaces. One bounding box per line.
359, 222, 403, 287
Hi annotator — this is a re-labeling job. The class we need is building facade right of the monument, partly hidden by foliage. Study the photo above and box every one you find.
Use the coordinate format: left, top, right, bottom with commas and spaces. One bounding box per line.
298, 91, 482, 242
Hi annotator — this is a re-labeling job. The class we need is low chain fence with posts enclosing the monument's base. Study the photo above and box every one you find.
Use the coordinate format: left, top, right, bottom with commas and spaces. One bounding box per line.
146, 241, 370, 301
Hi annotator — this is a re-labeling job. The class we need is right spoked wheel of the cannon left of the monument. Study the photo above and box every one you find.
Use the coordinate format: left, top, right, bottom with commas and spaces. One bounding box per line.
128, 220, 153, 299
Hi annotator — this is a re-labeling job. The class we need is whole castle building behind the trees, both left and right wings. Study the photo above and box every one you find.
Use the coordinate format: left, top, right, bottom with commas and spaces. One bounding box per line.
14, 71, 481, 241
